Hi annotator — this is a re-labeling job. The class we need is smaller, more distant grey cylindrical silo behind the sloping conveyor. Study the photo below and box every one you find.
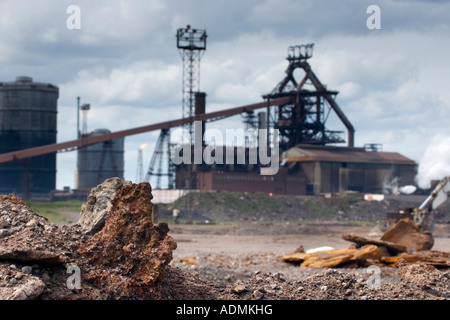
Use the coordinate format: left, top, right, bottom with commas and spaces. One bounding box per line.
77, 129, 125, 190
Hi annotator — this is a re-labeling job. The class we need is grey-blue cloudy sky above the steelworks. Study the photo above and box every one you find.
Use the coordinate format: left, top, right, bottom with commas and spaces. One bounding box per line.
0, 0, 450, 188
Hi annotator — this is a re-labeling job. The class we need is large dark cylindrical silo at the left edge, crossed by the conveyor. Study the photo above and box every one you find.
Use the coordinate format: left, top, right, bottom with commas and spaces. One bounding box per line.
0, 77, 59, 198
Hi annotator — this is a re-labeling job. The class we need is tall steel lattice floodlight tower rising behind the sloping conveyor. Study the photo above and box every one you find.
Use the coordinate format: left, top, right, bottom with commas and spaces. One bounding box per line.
177, 25, 208, 143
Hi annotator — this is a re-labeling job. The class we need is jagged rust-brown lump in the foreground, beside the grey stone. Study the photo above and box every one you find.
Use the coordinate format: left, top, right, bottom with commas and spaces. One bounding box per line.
79, 183, 177, 298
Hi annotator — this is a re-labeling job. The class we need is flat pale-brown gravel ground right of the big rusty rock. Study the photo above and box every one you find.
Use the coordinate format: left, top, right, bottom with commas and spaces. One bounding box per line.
163, 223, 450, 300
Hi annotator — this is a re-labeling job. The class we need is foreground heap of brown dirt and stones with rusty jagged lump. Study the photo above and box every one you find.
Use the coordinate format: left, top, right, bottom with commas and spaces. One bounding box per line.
0, 180, 176, 299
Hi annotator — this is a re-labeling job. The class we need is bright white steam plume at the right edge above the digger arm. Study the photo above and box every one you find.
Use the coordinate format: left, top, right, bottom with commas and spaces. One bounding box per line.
416, 134, 450, 189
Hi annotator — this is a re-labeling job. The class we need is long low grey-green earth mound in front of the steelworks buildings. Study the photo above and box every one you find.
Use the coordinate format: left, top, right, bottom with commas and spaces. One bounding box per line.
155, 191, 450, 223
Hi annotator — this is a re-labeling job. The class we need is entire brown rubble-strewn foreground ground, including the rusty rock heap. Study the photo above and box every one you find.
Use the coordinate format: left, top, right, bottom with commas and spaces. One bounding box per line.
0, 178, 450, 301
